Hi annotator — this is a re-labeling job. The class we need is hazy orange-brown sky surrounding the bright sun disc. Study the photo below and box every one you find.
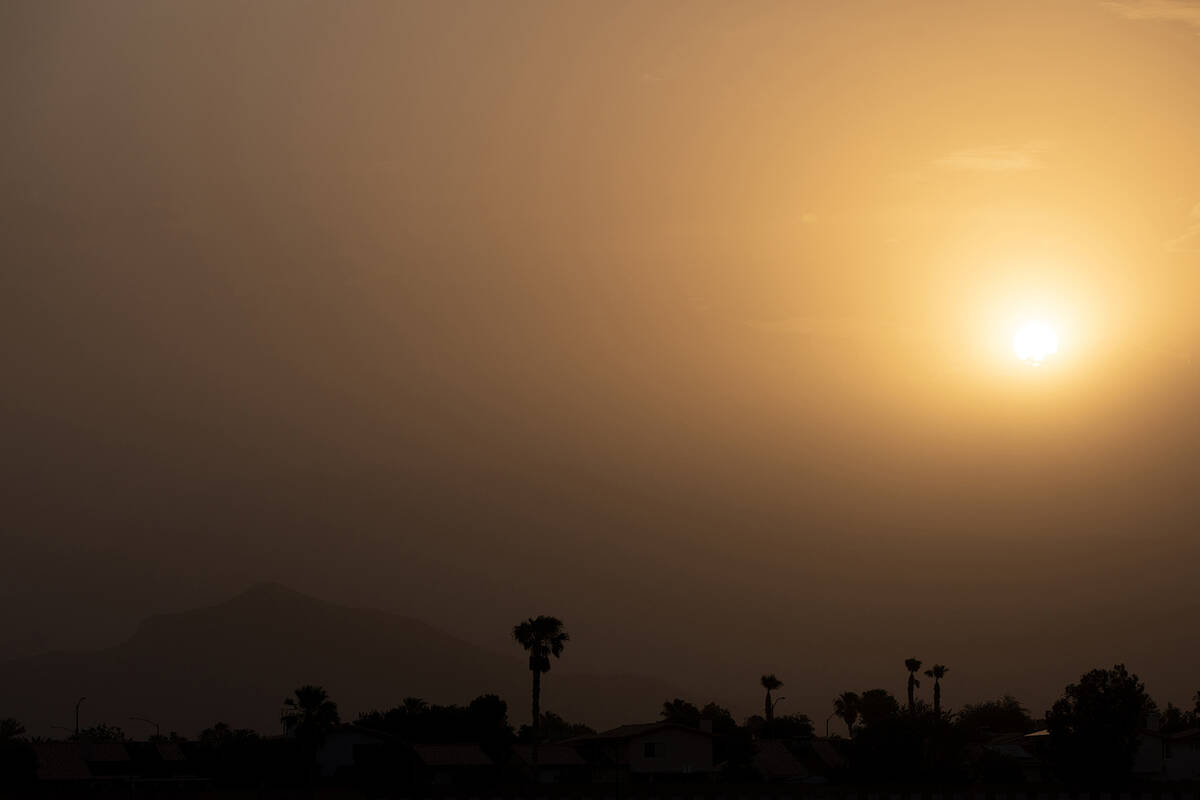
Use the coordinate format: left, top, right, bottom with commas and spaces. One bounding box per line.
0, 0, 1200, 720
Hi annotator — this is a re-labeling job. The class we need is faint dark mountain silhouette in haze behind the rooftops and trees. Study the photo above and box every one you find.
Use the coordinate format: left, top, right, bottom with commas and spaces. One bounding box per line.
0, 583, 682, 735
